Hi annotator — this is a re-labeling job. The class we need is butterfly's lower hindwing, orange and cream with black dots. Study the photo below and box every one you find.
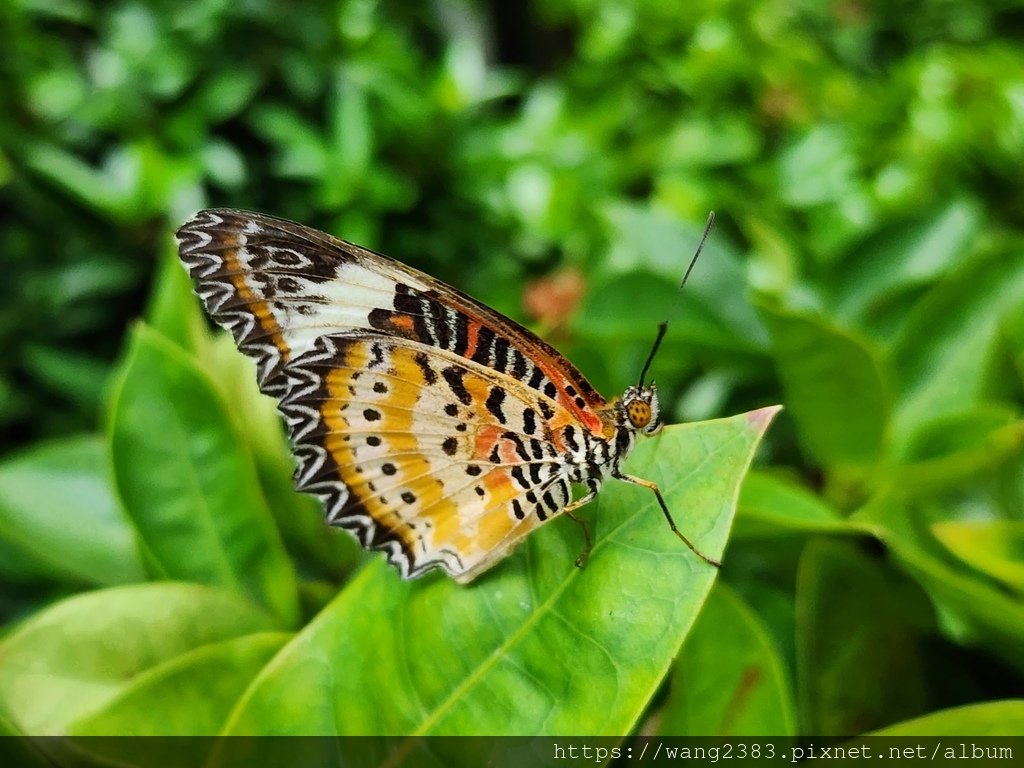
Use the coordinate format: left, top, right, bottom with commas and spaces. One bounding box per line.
281, 333, 585, 582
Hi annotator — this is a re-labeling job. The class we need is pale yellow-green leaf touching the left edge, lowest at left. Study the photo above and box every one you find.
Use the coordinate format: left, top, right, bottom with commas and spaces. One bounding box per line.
0, 583, 270, 735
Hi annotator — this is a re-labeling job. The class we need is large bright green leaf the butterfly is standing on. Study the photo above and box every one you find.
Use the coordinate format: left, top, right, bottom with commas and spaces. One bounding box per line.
216, 408, 776, 734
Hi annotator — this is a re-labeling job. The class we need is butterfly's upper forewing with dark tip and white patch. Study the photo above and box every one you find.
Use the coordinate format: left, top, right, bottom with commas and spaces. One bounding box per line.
177, 209, 607, 434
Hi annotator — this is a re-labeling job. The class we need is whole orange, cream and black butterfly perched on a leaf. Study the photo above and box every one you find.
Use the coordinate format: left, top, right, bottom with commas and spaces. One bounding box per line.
177, 209, 720, 583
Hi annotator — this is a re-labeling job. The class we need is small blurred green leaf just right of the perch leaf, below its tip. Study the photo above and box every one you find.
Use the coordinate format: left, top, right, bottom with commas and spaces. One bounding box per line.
736, 469, 850, 536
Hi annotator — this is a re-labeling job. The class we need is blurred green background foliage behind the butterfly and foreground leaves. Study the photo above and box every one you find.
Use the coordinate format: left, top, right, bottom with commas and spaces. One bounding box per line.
0, 0, 1024, 734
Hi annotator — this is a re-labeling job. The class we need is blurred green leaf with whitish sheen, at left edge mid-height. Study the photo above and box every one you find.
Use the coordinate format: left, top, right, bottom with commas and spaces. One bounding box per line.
0, 435, 143, 586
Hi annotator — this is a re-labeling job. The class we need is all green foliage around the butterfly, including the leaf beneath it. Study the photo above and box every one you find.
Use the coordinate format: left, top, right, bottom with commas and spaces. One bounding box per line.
0, 0, 1024, 736
